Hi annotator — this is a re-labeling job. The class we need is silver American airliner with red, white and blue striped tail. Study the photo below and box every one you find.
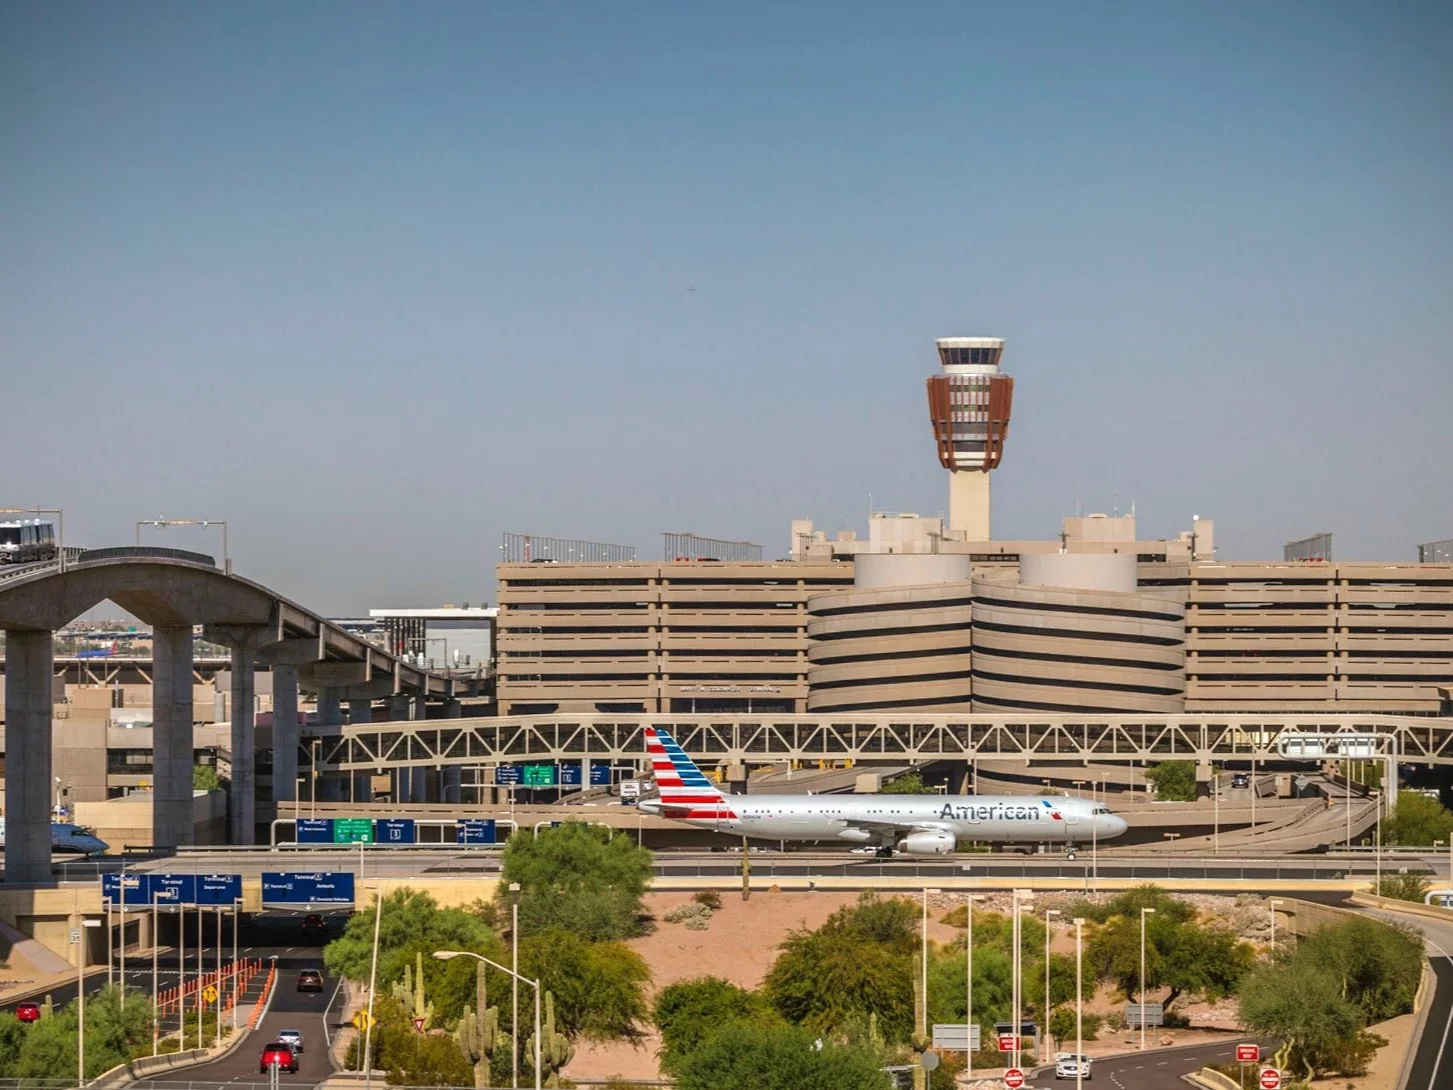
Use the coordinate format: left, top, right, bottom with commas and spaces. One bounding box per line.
636, 727, 1126, 859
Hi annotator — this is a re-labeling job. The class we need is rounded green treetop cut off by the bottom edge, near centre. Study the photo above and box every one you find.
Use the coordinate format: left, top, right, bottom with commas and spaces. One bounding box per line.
676, 1022, 892, 1090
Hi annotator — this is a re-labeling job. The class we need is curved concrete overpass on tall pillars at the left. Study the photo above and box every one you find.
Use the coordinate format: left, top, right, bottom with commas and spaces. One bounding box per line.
0, 548, 459, 884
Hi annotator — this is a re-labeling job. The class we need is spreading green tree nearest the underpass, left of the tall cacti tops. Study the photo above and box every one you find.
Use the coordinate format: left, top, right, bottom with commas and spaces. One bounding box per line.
323, 887, 504, 1023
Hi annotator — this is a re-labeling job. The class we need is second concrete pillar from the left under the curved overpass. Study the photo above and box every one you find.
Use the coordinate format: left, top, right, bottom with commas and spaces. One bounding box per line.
151, 625, 196, 847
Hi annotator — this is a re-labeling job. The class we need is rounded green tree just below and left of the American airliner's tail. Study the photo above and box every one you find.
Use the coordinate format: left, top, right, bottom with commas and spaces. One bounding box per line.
500, 821, 652, 942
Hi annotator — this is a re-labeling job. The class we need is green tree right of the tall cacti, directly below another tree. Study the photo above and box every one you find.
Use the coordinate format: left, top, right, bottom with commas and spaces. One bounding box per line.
520, 930, 651, 1041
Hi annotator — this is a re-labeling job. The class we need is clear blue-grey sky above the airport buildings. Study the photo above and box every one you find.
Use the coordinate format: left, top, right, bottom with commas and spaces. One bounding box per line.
0, 0, 1453, 615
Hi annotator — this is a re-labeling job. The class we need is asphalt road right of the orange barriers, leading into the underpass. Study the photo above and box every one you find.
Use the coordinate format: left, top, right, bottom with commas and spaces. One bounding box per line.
134, 917, 337, 1090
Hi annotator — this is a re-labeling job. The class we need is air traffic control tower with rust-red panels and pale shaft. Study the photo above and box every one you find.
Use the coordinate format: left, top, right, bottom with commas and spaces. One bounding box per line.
928, 337, 1014, 541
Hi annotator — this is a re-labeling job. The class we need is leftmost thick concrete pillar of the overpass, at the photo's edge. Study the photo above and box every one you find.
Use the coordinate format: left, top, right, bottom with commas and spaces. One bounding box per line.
4, 629, 54, 885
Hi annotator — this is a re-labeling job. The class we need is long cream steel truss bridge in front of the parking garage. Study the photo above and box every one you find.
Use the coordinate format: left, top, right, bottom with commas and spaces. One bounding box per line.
304, 714, 1453, 773
